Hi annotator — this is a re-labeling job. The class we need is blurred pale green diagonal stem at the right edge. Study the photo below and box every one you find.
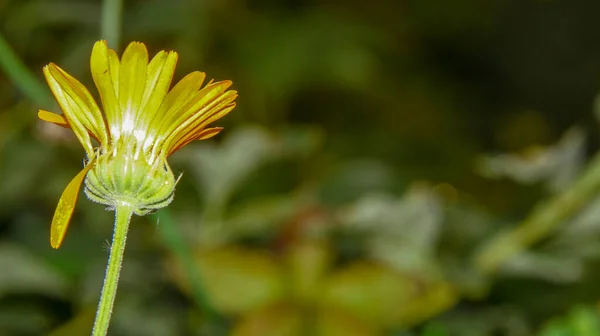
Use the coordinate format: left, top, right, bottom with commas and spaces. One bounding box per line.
474, 154, 600, 273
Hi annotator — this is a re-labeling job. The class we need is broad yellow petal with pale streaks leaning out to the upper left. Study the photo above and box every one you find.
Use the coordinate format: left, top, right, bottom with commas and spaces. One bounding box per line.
44, 63, 108, 157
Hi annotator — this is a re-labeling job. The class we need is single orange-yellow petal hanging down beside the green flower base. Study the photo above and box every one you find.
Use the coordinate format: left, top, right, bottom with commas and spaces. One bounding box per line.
50, 160, 96, 249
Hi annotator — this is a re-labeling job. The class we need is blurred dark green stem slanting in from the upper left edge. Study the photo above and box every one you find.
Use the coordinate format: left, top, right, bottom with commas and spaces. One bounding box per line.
0, 35, 53, 106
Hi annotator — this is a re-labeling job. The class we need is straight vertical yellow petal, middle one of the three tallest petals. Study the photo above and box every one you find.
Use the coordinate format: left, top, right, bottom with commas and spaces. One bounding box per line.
118, 42, 148, 134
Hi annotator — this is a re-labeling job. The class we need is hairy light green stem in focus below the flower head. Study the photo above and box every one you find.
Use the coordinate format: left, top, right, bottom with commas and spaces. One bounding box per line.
92, 205, 133, 336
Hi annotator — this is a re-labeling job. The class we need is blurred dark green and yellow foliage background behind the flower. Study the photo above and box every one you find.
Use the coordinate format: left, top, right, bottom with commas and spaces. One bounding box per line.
0, 0, 600, 336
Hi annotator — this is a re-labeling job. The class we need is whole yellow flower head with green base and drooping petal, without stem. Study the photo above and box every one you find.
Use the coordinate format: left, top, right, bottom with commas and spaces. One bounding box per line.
38, 41, 237, 248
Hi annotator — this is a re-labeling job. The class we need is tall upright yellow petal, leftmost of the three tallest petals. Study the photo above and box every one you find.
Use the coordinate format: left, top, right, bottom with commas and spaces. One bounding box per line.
90, 40, 121, 139
